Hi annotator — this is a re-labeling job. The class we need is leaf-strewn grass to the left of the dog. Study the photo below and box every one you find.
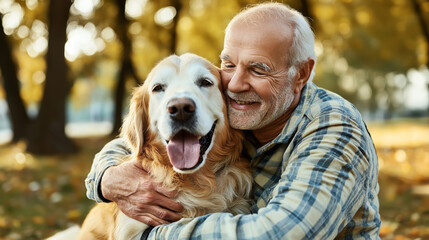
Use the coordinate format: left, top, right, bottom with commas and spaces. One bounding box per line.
0, 138, 107, 240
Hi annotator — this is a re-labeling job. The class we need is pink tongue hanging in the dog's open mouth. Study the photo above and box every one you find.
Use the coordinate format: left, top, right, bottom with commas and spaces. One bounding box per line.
167, 131, 200, 169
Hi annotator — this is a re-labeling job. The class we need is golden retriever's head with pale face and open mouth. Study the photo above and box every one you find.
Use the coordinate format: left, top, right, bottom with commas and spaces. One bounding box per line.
122, 54, 228, 173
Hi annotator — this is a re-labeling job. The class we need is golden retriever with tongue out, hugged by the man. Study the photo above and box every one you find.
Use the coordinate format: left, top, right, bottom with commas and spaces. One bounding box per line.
75, 53, 252, 240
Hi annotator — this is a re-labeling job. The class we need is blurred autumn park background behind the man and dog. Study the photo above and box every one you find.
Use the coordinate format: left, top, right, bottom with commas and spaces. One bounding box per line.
0, 0, 429, 239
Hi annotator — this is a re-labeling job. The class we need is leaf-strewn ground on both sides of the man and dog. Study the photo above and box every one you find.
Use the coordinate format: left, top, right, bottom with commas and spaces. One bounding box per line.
0, 120, 429, 240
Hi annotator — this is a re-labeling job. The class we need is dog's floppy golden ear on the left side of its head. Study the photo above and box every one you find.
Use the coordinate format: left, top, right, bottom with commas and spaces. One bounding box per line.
121, 85, 149, 155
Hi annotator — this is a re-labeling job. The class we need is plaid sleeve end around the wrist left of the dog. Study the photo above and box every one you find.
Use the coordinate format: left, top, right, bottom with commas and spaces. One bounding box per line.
85, 138, 131, 202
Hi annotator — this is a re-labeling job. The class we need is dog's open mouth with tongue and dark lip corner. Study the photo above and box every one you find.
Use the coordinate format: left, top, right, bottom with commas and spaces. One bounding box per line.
167, 121, 217, 171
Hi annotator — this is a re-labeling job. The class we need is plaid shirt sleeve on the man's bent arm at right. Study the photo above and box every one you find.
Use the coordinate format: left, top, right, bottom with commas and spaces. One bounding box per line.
145, 112, 371, 239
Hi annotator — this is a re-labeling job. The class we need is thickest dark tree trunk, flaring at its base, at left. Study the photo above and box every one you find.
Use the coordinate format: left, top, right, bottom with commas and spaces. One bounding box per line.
27, 0, 76, 154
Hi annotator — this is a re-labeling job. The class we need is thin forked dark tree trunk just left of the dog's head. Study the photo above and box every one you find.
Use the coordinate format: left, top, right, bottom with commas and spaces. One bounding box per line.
111, 0, 141, 136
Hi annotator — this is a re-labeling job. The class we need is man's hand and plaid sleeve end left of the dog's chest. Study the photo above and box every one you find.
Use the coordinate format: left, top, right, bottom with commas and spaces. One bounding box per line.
85, 138, 183, 226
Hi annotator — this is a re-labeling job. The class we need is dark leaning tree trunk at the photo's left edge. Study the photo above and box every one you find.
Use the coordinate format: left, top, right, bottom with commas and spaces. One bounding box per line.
0, 15, 29, 142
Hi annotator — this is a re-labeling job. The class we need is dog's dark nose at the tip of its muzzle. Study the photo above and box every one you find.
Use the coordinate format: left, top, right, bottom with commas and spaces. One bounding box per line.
167, 97, 196, 121
